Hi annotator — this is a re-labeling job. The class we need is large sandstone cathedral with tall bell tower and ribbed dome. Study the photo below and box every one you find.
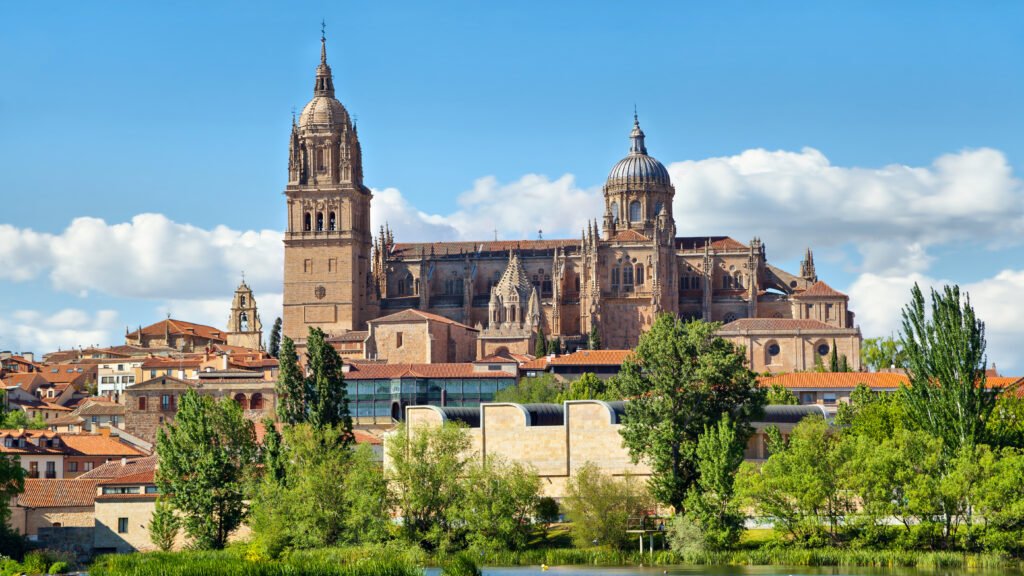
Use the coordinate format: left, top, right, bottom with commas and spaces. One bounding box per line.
284, 38, 860, 372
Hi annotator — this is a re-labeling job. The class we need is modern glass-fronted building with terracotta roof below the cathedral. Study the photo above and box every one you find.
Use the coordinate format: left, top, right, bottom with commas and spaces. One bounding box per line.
345, 363, 518, 424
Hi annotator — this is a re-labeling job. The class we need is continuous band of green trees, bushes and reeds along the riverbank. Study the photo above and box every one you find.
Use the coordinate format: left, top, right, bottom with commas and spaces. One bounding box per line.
132, 282, 1024, 576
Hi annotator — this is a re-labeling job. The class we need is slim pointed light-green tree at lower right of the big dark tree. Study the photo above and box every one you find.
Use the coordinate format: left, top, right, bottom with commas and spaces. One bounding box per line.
686, 414, 745, 549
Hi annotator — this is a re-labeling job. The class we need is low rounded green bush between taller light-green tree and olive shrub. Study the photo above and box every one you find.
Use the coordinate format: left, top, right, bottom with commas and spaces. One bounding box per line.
453, 456, 541, 550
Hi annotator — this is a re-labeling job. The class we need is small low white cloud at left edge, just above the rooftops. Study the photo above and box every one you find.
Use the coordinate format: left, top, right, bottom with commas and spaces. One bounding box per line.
0, 308, 119, 352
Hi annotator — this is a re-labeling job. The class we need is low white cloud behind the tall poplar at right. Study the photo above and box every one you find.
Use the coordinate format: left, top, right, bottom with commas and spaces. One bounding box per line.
850, 270, 1024, 375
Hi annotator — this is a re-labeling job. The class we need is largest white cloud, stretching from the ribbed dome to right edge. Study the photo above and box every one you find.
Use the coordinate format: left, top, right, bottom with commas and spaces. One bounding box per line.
669, 148, 1024, 274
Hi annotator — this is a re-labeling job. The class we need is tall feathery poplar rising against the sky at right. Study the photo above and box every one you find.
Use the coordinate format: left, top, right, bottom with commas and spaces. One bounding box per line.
900, 285, 998, 455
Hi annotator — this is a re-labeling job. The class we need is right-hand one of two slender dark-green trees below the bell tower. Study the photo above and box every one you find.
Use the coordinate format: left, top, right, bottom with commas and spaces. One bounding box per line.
305, 327, 352, 436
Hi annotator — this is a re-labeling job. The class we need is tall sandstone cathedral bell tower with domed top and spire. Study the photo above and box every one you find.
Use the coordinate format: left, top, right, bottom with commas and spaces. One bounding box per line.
283, 35, 376, 344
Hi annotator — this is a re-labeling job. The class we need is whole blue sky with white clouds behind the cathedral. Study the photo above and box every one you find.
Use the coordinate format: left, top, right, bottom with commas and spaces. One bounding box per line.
0, 1, 1024, 372
